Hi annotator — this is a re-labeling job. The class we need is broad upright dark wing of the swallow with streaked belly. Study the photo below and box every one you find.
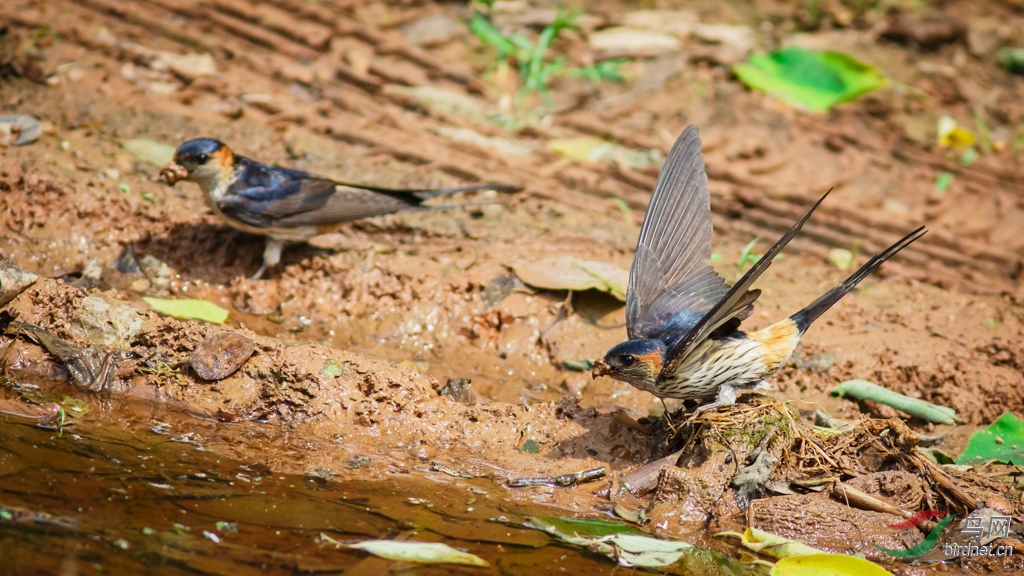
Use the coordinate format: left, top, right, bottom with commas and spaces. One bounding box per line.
626, 126, 749, 339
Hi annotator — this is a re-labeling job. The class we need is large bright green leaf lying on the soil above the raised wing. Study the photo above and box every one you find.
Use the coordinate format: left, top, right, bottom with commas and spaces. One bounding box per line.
732, 46, 886, 111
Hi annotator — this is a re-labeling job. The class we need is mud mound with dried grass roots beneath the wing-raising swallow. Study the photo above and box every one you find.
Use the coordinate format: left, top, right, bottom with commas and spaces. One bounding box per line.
622, 396, 1020, 563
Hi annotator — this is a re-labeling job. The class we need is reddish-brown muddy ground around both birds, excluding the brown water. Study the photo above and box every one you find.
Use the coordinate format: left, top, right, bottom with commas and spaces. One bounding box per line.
0, 0, 1024, 574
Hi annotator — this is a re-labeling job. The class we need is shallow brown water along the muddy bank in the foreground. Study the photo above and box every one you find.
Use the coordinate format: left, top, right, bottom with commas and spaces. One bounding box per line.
0, 381, 753, 576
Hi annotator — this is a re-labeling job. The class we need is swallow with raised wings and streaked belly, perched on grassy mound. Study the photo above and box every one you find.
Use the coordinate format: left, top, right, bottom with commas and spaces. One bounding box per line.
593, 126, 927, 415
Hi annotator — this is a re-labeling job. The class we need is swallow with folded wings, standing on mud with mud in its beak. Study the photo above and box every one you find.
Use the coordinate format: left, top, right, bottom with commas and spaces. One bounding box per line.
160, 138, 519, 280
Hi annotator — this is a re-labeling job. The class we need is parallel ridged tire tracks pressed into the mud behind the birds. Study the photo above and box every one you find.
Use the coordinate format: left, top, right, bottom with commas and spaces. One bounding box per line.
3, 0, 1024, 293
